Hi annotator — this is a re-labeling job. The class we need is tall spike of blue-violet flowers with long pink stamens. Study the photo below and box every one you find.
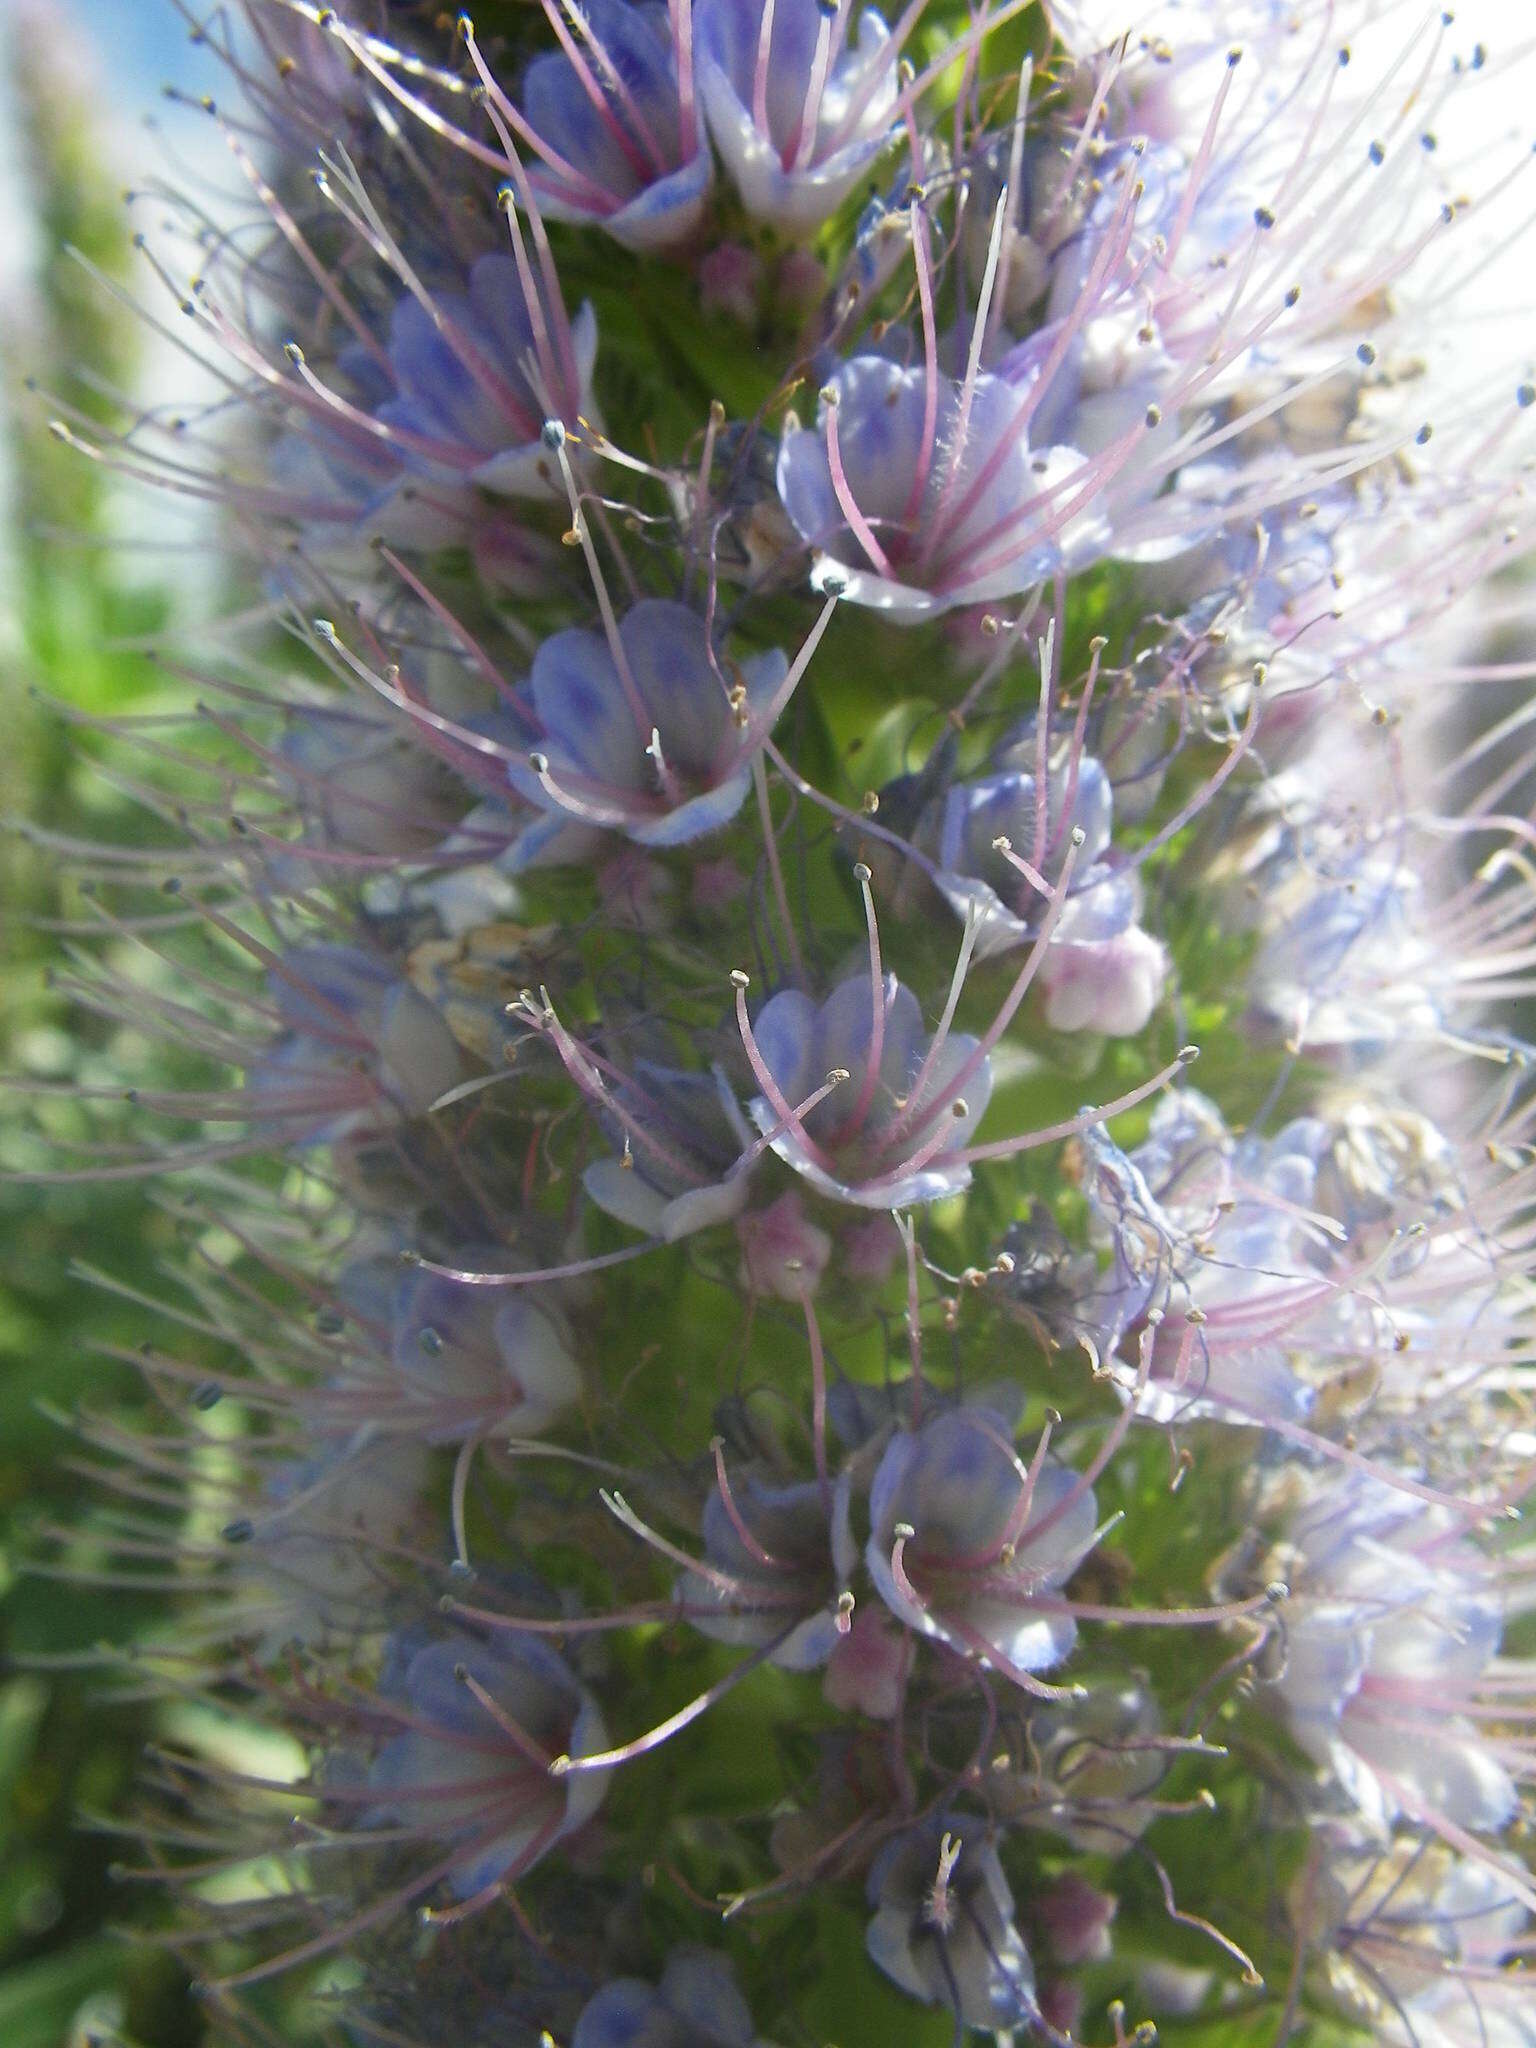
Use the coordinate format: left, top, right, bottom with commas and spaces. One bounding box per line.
30, 0, 1536, 2048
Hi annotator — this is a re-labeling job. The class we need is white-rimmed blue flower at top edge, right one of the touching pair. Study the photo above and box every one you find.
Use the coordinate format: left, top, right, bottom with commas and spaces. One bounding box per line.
694, 0, 897, 238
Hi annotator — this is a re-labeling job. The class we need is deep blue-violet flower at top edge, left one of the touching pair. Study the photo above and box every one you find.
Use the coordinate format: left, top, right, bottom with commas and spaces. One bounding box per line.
522, 0, 713, 252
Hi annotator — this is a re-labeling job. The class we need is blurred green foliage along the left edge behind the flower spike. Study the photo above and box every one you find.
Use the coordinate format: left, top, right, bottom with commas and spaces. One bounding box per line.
0, 18, 199, 2048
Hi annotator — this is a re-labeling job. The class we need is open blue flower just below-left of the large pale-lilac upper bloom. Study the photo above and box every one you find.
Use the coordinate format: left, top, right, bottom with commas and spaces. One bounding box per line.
508, 598, 788, 866
